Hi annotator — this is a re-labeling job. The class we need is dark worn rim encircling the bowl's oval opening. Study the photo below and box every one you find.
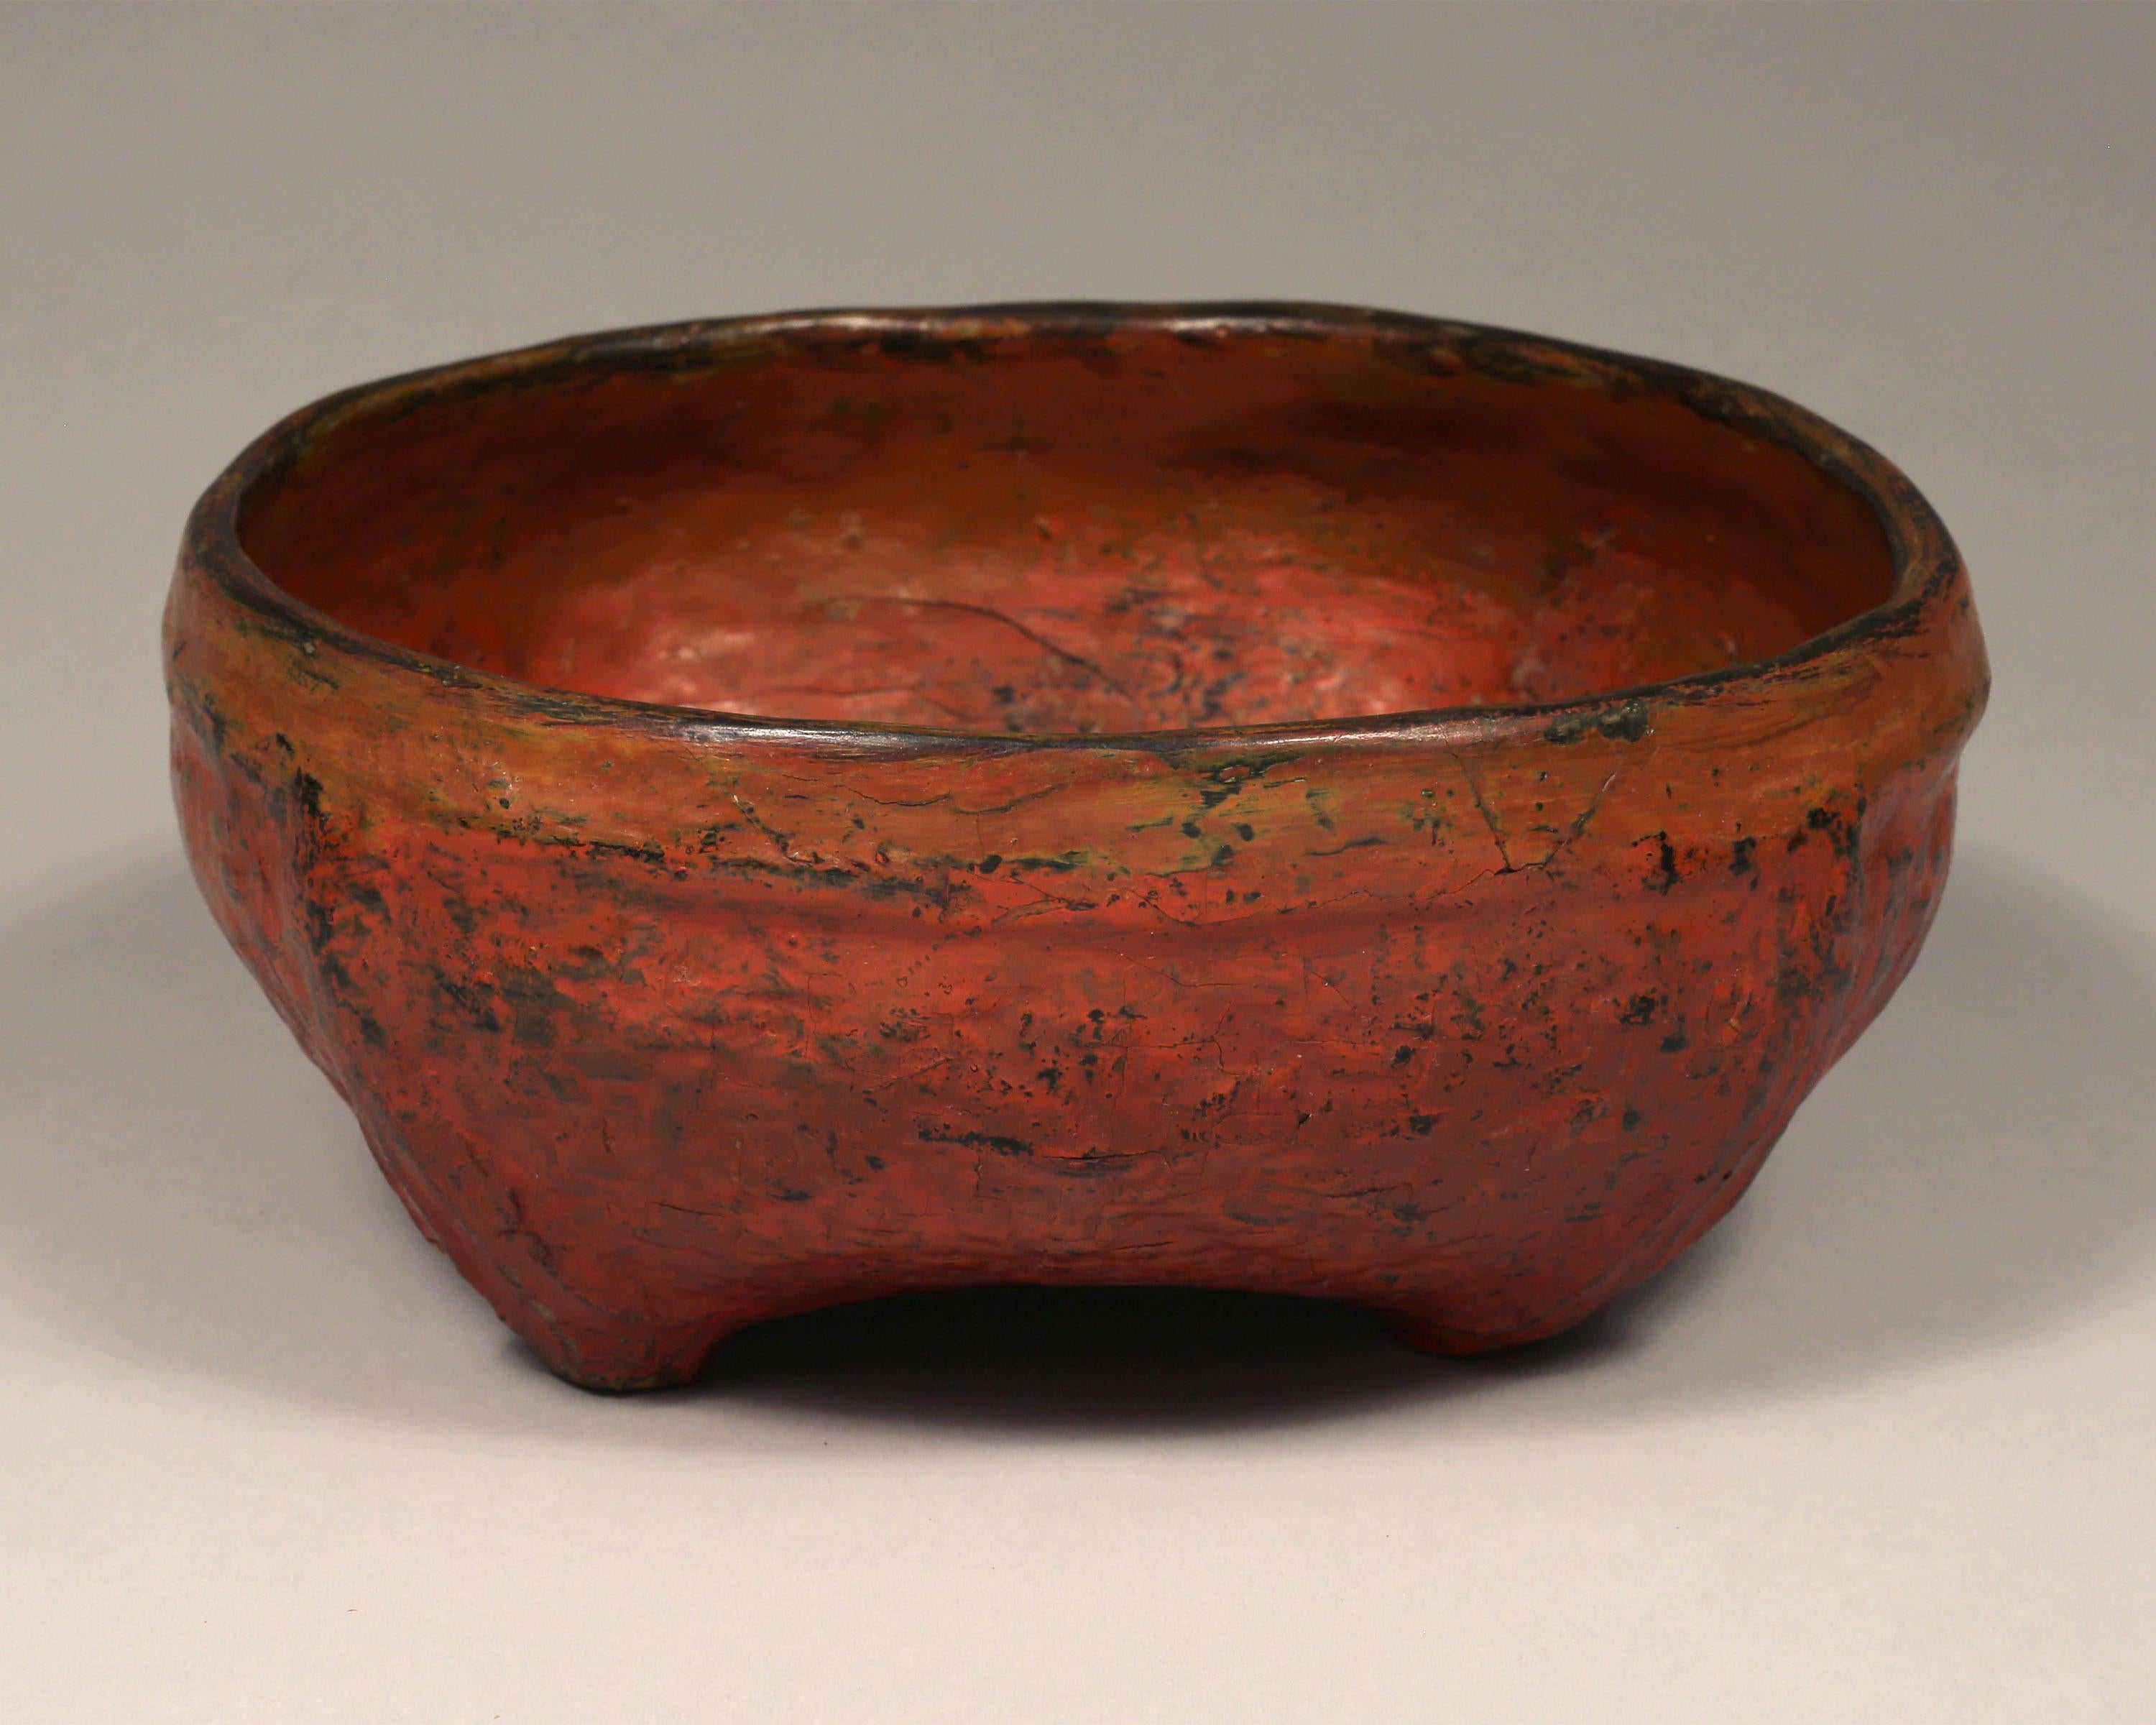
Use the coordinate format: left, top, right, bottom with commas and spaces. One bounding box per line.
181, 300, 1964, 757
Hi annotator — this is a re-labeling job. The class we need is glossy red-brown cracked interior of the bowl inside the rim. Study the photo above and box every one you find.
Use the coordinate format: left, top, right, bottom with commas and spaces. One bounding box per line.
241, 328, 1893, 733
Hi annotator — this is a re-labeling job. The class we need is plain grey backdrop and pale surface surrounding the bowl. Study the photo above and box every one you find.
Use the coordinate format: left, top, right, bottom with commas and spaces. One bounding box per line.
0, 4, 2156, 1725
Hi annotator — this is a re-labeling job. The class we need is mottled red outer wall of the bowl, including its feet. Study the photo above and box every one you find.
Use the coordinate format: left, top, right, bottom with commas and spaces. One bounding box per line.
168, 565, 1981, 1386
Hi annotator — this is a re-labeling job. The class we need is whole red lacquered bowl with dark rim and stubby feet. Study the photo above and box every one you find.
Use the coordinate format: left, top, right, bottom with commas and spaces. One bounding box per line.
166, 304, 1986, 1389
